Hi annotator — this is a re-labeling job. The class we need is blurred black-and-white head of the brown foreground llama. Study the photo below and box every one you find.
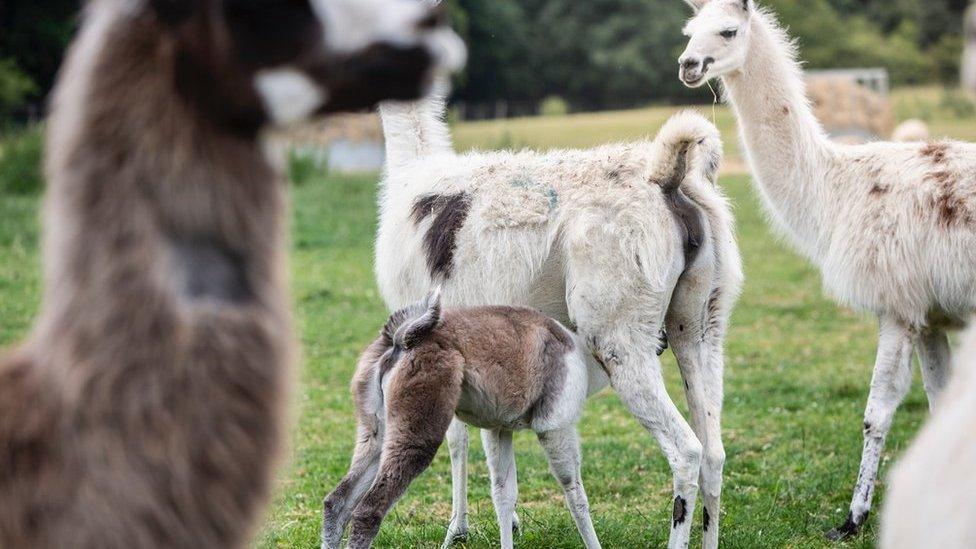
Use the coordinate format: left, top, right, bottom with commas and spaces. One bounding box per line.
126, 0, 465, 125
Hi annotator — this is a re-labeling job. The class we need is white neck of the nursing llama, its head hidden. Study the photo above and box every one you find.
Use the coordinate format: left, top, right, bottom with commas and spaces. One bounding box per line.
380, 81, 453, 170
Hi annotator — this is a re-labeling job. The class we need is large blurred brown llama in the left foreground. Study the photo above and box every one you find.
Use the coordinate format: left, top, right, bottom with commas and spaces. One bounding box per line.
0, 0, 460, 548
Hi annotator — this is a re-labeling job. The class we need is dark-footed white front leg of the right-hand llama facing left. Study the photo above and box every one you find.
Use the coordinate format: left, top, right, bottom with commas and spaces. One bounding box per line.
827, 318, 913, 541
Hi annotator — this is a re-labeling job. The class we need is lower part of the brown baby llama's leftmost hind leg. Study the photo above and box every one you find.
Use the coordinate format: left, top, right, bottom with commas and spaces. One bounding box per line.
322, 416, 383, 549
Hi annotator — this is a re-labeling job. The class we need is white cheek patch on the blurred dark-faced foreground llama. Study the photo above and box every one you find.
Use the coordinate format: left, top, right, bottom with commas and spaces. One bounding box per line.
254, 68, 328, 124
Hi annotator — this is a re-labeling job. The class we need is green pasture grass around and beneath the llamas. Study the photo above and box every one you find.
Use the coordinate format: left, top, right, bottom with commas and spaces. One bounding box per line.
0, 168, 926, 548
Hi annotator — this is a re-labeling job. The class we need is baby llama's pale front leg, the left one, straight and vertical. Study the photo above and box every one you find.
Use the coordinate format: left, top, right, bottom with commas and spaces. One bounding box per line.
481, 429, 518, 549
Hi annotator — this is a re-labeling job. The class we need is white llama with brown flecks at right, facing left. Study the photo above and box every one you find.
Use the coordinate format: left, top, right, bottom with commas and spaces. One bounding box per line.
679, 0, 976, 539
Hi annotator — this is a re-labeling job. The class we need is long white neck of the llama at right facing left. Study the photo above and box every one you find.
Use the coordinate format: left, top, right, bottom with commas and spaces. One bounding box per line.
723, 10, 832, 258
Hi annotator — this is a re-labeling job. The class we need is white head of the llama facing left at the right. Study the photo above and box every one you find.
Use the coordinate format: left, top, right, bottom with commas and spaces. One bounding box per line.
678, 0, 756, 88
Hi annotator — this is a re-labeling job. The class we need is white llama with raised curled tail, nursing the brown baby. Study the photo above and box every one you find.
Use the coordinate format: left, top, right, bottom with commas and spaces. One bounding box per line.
364, 93, 742, 547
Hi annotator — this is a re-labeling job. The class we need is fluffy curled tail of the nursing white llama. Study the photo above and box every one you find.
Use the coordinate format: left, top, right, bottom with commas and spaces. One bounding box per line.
651, 111, 722, 191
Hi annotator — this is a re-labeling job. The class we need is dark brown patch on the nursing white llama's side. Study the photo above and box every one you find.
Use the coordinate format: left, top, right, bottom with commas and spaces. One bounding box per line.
412, 193, 471, 280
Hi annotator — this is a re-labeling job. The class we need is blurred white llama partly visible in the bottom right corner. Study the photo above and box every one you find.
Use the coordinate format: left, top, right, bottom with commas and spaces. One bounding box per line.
881, 329, 976, 549
